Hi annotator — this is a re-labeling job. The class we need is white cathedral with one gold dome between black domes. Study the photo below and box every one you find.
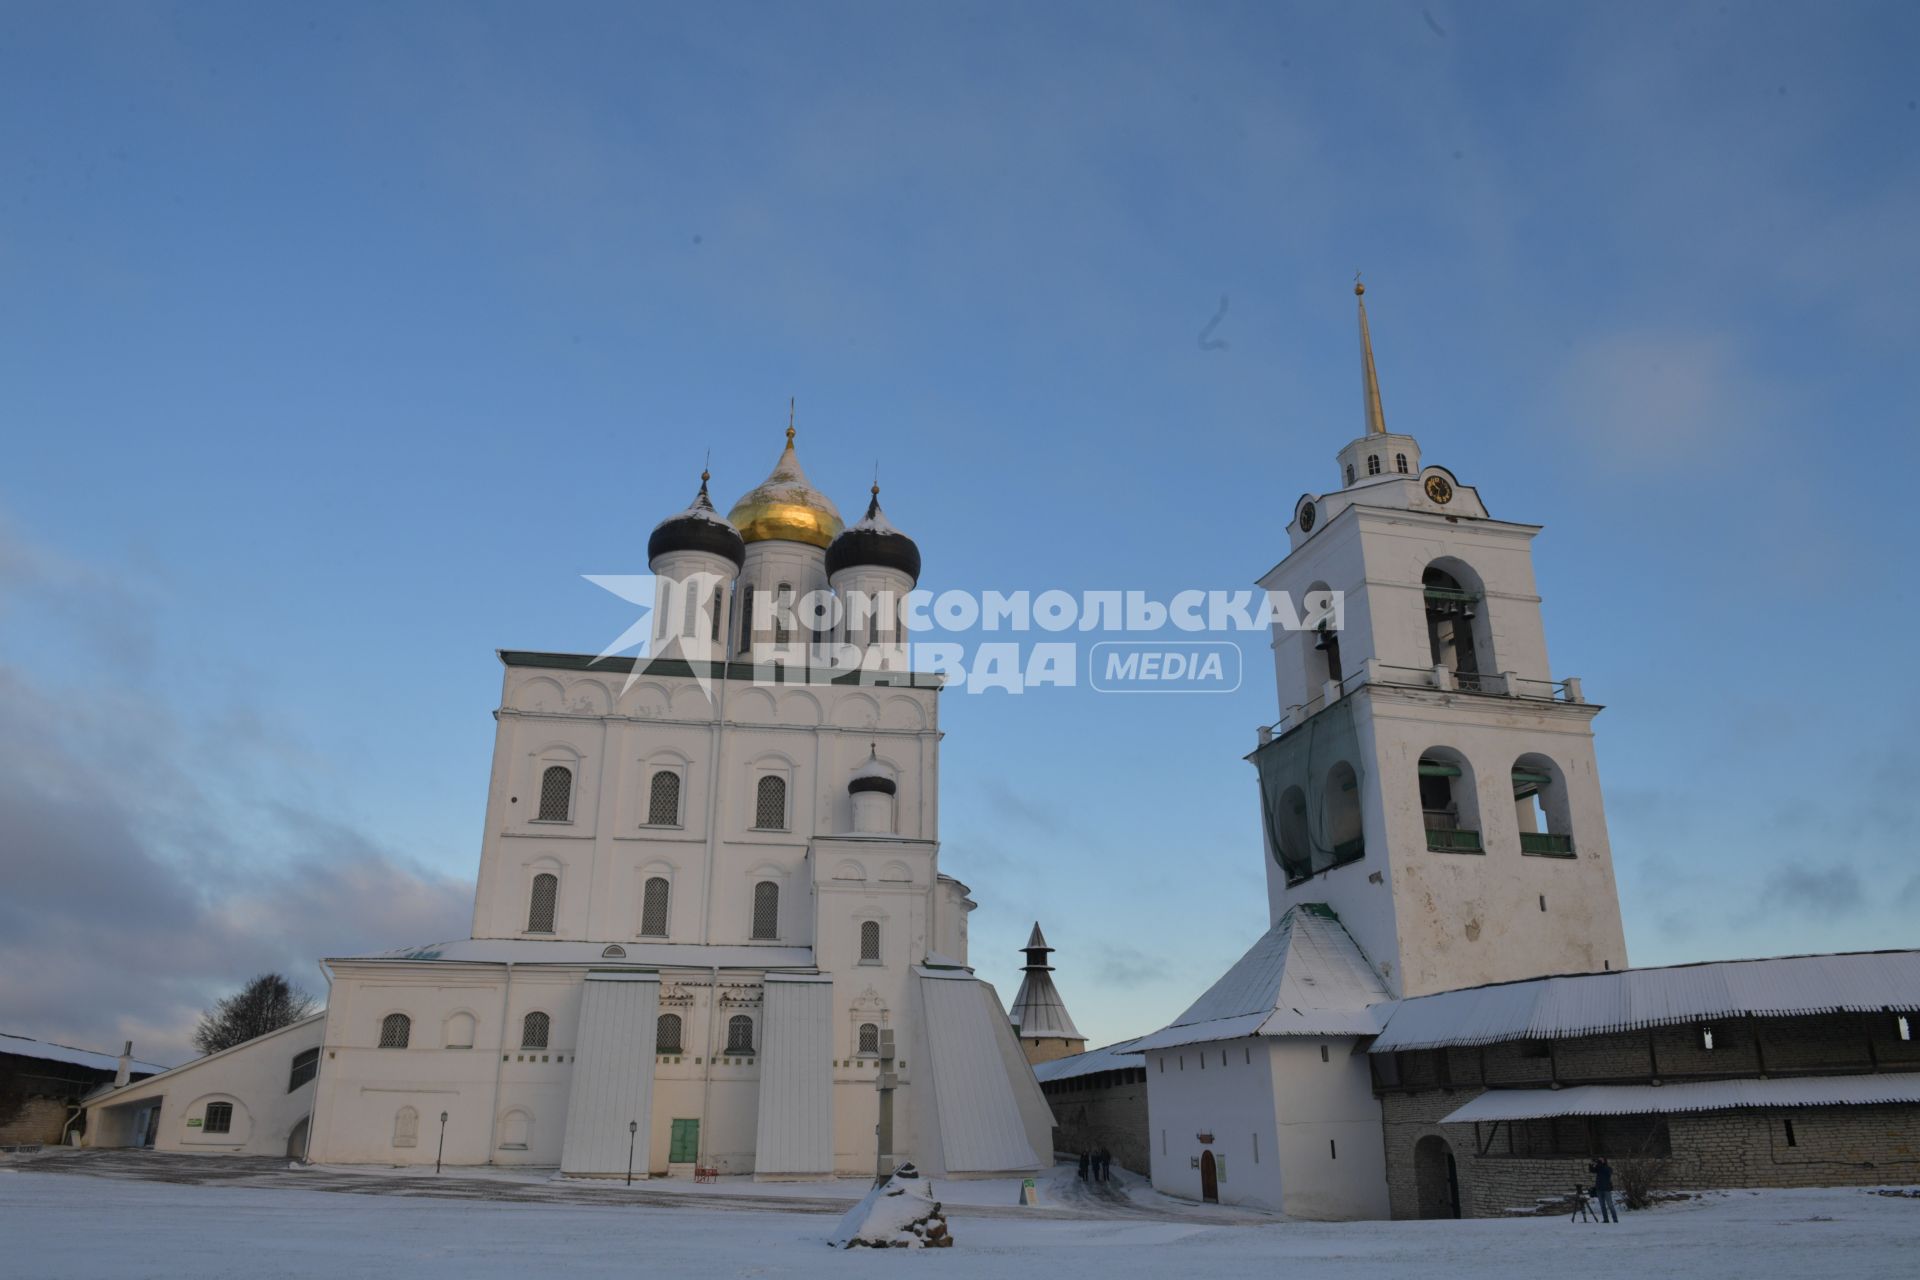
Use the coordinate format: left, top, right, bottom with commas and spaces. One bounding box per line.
86, 426, 1052, 1178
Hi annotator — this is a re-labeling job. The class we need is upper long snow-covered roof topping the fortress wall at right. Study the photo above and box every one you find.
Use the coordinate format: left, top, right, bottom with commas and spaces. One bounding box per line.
1373, 952, 1920, 1054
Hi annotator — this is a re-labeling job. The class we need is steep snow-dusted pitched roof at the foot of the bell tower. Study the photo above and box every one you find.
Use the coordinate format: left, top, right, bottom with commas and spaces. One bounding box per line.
1135, 904, 1392, 1050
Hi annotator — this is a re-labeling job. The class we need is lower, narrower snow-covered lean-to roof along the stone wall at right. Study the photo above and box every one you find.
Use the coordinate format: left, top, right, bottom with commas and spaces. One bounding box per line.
1440, 1073, 1920, 1125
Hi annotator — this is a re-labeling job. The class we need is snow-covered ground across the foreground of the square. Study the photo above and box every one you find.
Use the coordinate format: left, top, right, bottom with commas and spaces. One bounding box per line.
0, 1169, 1920, 1280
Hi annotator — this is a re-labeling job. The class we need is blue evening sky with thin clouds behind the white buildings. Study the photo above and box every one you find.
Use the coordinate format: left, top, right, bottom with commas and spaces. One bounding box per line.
0, 0, 1920, 1052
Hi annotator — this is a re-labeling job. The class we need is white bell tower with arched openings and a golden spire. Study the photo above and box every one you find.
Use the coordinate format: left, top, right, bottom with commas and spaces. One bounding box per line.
1250, 282, 1626, 996
